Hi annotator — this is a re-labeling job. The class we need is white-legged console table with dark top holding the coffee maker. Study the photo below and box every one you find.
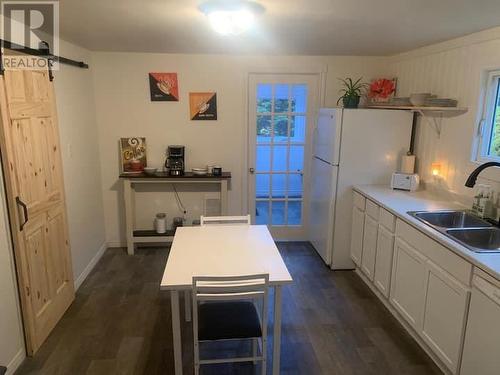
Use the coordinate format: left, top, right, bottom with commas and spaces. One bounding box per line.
120, 172, 231, 255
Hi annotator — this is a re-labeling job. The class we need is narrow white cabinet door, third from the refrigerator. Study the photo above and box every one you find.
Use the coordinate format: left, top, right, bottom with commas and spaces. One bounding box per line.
373, 225, 394, 298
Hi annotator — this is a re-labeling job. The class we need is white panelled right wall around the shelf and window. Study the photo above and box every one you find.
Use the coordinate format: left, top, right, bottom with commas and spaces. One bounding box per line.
391, 28, 500, 196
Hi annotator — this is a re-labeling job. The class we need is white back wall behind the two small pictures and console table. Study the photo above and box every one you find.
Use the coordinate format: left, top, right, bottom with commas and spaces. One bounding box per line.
93, 53, 388, 245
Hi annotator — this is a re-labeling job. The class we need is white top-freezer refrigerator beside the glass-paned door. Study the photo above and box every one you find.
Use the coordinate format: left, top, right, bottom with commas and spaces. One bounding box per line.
308, 108, 413, 270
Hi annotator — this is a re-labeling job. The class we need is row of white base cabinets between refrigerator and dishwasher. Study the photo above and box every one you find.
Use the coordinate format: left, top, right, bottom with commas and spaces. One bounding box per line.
351, 194, 472, 375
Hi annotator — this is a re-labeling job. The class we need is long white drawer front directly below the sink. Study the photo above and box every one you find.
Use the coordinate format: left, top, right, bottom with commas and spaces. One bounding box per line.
396, 219, 472, 286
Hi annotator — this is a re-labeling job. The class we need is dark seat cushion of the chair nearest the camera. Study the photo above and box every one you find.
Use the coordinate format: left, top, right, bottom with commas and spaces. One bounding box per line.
198, 301, 262, 341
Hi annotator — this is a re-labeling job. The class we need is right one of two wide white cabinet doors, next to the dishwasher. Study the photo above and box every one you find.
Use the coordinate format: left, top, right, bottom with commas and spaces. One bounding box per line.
422, 261, 470, 373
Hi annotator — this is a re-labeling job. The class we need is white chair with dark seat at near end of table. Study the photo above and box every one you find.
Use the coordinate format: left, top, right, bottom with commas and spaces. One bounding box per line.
193, 274, 269, 375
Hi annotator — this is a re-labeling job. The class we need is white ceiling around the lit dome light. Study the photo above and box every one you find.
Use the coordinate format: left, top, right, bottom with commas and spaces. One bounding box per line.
60, 0, 500, 55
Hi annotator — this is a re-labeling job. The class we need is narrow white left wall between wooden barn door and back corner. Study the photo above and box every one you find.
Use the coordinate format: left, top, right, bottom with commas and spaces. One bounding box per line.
54, 41, 105, 286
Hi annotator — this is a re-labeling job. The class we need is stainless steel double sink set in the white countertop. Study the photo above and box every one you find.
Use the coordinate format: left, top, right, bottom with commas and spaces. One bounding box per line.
408, 210, 500, 253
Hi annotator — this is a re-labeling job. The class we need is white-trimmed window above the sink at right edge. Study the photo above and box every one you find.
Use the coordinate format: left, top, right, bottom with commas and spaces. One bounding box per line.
477, 70, 500, 161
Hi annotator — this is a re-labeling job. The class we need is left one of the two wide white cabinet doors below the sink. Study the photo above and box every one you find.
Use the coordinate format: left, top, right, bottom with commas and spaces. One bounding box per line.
390, 238, 426, 332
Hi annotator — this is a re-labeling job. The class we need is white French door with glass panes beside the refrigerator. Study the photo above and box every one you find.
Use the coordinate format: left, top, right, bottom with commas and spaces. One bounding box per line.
248, 74, 319, 240
